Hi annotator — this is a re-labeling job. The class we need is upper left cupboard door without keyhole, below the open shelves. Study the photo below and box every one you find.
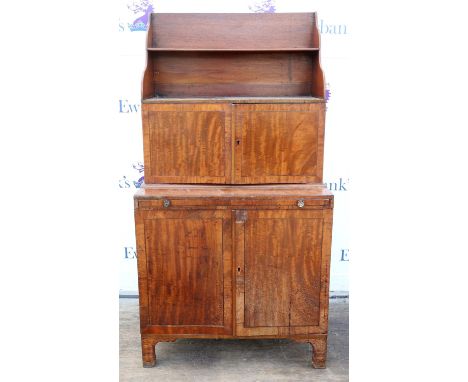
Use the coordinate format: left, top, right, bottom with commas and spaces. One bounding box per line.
143, 104, 232, 183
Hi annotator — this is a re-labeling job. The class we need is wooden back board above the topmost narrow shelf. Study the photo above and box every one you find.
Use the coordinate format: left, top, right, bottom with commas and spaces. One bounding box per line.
151, 13, 315, 49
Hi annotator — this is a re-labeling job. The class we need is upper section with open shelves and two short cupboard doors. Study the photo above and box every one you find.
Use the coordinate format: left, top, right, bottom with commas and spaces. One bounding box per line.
142, 13, 325, 184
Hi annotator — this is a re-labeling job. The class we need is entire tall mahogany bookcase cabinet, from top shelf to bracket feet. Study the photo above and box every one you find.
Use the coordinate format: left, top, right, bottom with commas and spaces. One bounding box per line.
135, 13, 333, 367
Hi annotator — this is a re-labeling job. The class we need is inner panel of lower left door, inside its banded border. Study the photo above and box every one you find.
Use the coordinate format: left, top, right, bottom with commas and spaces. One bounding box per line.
145, 213, 223, 326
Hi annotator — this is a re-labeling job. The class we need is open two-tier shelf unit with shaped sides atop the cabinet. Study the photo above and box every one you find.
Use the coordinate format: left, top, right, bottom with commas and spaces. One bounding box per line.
142, 13, 325, 99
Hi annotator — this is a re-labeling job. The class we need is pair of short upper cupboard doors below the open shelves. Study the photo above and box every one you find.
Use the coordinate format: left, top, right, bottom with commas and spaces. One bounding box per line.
143, 98, 325, 184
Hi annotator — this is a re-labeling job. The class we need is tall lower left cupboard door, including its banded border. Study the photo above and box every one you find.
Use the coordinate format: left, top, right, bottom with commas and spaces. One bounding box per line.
136, 210, 232, 334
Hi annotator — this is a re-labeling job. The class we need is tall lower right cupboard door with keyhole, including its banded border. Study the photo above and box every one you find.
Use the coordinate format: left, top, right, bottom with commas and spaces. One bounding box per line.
235, 210, 331, 336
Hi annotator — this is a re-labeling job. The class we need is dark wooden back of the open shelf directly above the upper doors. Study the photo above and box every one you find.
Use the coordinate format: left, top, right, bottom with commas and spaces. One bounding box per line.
153, 52, 318, 97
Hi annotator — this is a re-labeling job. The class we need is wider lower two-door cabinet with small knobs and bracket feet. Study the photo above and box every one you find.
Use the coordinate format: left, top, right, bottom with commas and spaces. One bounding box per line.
135, 185, 333, 367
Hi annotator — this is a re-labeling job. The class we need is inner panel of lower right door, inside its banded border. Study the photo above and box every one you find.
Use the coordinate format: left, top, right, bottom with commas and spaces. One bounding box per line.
244, 211, 322, 327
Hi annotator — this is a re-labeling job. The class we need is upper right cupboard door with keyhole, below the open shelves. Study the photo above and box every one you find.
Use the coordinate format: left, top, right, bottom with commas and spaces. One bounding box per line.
234, 103, 325, 183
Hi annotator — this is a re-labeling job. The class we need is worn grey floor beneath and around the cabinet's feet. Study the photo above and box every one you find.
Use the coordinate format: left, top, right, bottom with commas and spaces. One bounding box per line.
120, 298, 349, 382
